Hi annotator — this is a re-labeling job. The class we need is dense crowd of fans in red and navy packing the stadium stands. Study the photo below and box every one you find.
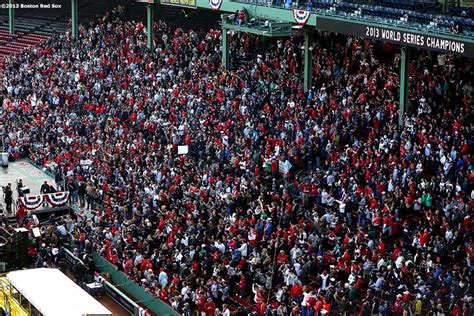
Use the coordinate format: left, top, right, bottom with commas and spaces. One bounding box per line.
0, 9, 474, 316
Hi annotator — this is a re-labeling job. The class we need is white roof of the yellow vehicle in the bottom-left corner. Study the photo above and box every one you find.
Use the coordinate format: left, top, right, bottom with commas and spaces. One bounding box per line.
7, 268, 112, 316
